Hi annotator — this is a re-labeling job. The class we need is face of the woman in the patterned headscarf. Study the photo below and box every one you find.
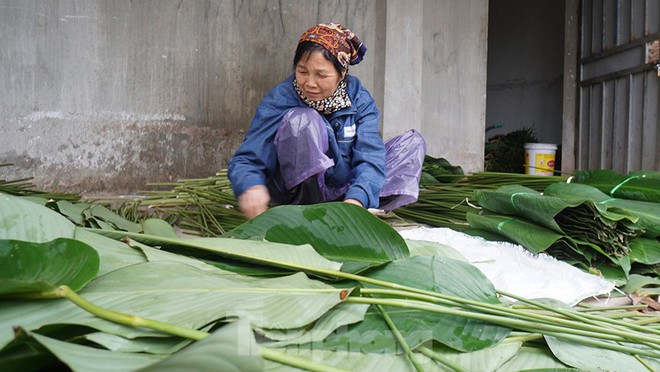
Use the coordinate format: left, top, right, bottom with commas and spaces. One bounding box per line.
296, 51, 344, 101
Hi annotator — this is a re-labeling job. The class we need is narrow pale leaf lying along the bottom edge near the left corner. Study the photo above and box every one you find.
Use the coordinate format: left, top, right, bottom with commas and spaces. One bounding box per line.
32, 333, 163, 372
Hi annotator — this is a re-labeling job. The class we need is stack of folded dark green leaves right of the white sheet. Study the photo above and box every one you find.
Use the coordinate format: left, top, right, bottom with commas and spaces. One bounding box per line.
467, 183, 660, 279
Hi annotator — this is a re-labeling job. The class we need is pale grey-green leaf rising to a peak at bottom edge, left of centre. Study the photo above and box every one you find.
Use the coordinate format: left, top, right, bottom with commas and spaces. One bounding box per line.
142, 321, 264, 372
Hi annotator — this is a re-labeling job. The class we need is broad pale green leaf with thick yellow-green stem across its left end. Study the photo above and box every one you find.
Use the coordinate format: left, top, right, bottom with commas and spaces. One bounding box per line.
0, 262, 346, 345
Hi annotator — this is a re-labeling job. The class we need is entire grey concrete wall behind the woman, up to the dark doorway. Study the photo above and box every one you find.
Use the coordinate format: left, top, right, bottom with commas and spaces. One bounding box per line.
0, 0, 487, 193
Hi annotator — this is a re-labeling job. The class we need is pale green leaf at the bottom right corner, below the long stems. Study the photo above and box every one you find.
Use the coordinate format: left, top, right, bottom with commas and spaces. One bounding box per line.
544, 336, 660, 371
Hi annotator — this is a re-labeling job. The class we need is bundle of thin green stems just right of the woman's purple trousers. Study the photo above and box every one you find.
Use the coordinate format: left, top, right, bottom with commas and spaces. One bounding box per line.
394, 172, 568, 230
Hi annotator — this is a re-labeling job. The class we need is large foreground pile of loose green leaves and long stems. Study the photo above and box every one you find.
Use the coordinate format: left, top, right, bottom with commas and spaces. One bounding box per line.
0, 195, 660, 371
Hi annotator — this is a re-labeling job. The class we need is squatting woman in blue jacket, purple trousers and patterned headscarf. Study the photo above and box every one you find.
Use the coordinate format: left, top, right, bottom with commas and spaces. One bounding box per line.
229, 23, 425, 219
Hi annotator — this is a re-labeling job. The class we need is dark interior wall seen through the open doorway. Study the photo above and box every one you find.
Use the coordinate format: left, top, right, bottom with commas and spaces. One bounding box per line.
486, 0, 564, 144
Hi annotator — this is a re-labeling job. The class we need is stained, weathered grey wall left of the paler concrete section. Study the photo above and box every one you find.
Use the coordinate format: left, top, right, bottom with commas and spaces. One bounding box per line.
0, 0, 375, 192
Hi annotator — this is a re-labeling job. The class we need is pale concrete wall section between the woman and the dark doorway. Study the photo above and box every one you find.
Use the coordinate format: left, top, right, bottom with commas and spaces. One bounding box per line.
382, 0, 488, 171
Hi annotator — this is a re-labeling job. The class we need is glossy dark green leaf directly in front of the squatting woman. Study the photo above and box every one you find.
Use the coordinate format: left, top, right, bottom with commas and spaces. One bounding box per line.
223, 203, 409, 273
